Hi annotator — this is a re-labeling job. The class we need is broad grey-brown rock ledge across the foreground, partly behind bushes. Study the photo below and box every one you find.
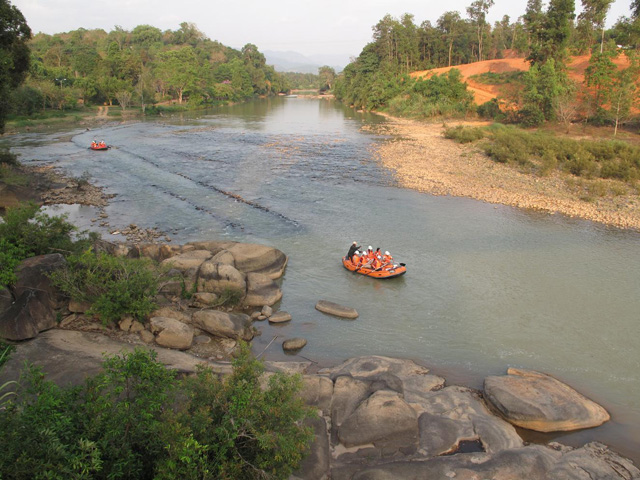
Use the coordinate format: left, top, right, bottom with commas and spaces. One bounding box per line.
0, 329, 640, 480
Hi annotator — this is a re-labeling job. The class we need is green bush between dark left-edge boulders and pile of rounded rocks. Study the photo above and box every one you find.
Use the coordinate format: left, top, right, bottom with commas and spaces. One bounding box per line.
51, 251, 162, 324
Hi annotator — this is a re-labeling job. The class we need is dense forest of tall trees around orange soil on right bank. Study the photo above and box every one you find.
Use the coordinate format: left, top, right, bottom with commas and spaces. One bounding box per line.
334, 0, 640, 126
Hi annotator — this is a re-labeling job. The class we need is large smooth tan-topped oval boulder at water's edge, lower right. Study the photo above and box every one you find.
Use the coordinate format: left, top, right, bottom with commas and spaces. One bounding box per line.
484, 368, 609, 432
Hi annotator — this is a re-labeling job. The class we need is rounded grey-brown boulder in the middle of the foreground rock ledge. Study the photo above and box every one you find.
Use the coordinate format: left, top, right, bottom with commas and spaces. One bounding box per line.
338, 390, 418, 451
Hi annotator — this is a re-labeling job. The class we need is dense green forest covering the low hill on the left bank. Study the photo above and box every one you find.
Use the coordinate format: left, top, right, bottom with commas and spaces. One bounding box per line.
12, 22, 290, 114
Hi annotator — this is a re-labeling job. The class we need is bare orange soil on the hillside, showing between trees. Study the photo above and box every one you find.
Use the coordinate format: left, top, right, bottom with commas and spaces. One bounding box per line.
411, 55, 629, 105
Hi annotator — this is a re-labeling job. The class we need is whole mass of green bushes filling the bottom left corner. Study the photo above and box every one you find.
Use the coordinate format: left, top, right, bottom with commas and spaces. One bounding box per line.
0, 346, 312, 480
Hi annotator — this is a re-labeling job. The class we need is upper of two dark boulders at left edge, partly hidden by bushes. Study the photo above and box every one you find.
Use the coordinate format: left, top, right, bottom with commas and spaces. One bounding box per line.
13, 253, 67, 308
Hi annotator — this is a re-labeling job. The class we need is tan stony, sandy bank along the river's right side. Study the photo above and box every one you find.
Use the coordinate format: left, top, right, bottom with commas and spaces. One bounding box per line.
372, 117, 640, 229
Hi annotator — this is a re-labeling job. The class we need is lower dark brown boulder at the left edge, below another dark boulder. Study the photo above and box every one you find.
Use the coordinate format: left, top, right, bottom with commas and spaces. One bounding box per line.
0, 290, 56, 341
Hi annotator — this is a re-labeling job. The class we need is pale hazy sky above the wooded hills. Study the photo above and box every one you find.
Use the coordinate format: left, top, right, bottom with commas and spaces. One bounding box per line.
10, 0, 631, 56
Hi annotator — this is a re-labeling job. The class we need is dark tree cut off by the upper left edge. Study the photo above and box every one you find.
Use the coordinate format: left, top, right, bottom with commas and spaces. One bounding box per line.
0, 0, 31, 134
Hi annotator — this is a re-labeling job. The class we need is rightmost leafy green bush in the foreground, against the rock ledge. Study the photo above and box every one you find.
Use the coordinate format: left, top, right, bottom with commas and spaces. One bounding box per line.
179, 345, 313, 479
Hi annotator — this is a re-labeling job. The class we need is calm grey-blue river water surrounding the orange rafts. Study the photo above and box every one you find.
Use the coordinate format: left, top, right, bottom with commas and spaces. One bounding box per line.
3, 98, 640, 463
